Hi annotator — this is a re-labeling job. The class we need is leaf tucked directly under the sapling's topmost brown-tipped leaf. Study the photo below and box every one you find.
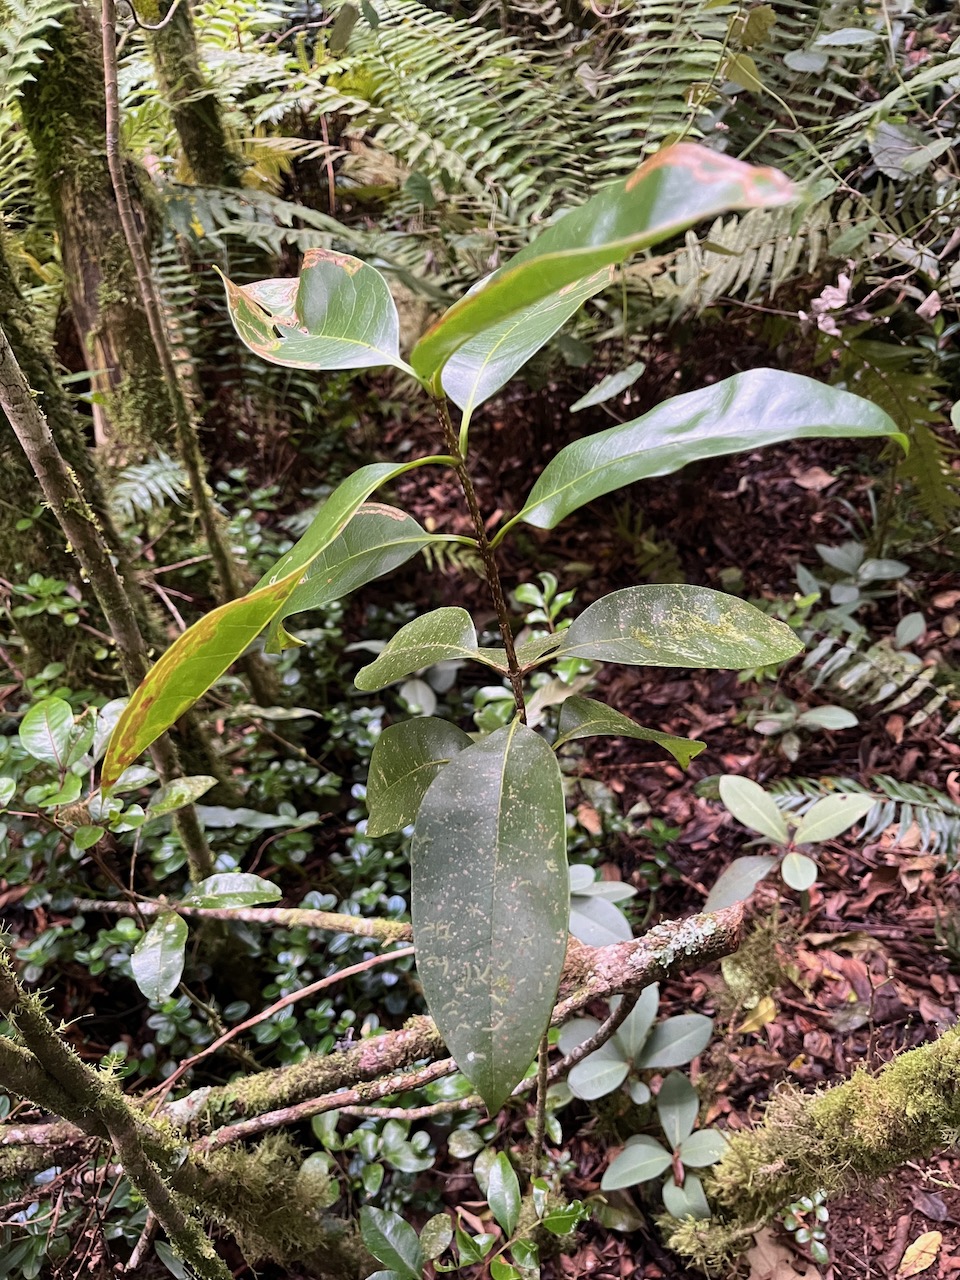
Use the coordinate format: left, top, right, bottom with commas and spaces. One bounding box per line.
442, 268, 611, 417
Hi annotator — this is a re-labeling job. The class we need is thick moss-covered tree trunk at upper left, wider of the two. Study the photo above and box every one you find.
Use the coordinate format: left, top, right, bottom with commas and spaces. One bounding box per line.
20, 4, 173, 461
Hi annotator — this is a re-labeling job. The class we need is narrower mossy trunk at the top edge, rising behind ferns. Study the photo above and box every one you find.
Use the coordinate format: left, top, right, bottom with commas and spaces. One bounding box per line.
145, 0, 243, 187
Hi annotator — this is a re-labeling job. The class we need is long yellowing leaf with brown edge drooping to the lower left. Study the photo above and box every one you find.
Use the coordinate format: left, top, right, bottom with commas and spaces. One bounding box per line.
101, 462, 416, 790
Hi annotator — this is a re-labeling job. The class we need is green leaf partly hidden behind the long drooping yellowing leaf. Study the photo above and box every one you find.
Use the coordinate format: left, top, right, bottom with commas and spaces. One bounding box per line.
265, 502, 438, 653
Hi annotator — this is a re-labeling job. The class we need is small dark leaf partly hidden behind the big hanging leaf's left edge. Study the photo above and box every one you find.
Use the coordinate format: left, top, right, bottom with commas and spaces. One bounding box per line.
366, 716, 471, 836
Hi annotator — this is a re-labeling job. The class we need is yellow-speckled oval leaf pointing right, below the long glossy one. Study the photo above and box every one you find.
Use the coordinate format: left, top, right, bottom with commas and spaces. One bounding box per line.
553, 586, 803, 671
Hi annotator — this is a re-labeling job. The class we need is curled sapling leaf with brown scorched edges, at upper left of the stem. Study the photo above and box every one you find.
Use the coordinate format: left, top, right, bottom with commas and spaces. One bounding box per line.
224, 248, 412, 372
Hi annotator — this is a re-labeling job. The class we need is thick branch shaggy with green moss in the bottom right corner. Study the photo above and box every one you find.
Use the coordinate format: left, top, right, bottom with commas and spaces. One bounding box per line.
668, 1028, 960, 1272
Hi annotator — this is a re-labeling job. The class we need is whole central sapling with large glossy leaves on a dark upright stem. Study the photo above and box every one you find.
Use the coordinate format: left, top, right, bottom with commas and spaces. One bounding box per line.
94, 145, 897, 1121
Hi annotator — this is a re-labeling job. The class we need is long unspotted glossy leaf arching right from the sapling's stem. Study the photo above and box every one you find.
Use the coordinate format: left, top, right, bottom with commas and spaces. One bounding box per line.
515, 369, 906, 529
